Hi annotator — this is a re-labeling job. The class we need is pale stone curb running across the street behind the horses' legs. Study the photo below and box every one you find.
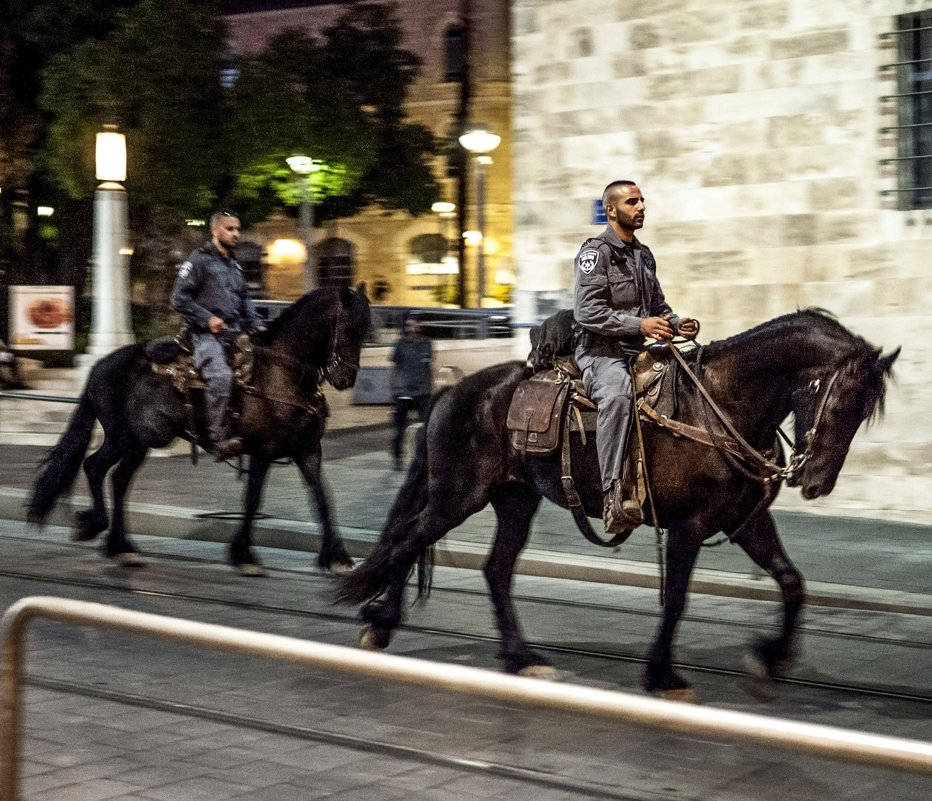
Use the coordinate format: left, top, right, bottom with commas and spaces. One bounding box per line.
0, 487, 932, 617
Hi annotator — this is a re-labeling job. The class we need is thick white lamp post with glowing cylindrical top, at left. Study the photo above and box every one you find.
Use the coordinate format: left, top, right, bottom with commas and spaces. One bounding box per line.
84, 125, 134, 367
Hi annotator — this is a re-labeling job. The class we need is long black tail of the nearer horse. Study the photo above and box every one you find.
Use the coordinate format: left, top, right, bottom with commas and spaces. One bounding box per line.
336, 387, 451, 606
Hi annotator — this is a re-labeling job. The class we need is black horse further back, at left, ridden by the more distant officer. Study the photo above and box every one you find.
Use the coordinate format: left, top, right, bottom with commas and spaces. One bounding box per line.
28, 286, 370, 575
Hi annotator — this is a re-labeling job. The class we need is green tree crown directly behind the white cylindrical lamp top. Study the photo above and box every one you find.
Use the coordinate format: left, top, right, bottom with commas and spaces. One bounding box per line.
41, 0, 225, 211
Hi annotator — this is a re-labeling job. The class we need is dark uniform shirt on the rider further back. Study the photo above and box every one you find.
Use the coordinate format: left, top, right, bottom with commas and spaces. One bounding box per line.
171, 242, 262, 332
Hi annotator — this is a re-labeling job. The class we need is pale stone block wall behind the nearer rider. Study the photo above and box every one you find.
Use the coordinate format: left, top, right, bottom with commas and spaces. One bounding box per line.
512, 0, 932, 522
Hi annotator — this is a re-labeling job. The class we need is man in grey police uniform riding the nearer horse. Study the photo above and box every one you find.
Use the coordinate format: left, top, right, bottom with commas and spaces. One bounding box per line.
573, 181, 699, 534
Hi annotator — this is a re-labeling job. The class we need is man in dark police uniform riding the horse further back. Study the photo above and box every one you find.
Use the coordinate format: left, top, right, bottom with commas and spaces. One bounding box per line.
171, 211, 265, 461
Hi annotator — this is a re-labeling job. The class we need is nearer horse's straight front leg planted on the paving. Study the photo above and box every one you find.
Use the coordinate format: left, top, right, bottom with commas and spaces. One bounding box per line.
644, 526, 703, 702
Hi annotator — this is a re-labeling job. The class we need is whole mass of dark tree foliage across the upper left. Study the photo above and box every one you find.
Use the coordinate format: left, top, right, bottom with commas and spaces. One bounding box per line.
0, 0, 440, 284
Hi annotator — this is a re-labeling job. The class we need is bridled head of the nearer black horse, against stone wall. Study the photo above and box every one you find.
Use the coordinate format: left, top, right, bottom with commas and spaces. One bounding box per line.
787, 348, 900, 500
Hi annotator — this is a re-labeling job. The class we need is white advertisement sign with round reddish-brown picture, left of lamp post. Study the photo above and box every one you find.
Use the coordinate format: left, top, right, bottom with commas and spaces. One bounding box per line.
9, 286, 74, 350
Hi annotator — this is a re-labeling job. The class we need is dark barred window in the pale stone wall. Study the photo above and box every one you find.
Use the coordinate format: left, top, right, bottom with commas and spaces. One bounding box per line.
883, 11, 932, 209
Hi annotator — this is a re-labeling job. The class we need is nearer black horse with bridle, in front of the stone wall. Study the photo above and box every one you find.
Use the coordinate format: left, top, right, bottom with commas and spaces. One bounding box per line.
338, 310, 899, 698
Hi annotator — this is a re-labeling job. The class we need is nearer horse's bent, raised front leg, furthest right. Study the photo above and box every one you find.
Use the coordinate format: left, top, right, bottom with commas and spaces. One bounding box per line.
733, 510, 805, 679
